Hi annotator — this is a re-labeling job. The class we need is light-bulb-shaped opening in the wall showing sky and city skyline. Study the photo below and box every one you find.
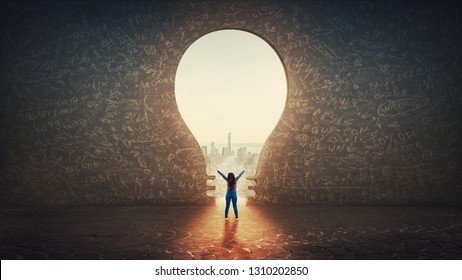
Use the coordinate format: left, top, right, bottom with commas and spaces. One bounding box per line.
175, 29, 288, 205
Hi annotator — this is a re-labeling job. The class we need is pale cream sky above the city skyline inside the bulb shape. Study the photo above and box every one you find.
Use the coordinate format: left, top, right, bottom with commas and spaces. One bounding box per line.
175, 30, 287, 145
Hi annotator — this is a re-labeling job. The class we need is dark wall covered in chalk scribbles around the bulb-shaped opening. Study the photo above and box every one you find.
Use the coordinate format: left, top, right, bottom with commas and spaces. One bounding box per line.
0, 1, 462, 205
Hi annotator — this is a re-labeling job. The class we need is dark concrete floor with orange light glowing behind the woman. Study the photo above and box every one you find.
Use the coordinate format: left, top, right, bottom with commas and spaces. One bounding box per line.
0, 206, 462, 259
